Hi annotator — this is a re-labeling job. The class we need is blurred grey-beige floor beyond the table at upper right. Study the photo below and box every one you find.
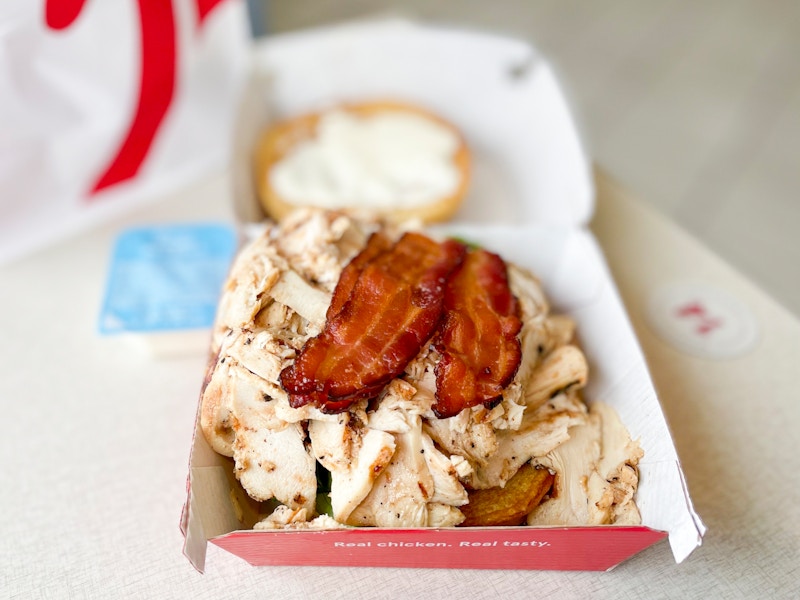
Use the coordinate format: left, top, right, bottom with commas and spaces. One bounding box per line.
249, 0, 800, 315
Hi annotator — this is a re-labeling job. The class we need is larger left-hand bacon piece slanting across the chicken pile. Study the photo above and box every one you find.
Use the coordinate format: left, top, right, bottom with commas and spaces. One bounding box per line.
281, 233, 466, 413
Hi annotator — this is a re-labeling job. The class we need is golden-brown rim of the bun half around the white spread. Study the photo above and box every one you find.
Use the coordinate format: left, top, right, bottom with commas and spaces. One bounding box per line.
254, 101, 470, 223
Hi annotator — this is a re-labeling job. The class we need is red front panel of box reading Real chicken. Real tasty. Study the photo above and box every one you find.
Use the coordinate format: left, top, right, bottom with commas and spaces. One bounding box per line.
208, 526, 667, 571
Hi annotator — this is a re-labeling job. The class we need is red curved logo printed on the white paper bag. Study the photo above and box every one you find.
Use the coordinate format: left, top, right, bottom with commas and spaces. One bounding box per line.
45, 0, 224, 194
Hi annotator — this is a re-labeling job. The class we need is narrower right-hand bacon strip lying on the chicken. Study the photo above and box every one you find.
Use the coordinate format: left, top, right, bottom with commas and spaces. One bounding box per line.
433, 250, 522, 418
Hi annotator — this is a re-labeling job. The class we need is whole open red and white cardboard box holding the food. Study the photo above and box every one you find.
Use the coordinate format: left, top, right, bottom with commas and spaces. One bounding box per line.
181, 20, 705, 570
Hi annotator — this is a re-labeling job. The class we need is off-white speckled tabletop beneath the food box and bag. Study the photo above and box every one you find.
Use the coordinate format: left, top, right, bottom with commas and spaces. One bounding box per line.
0, 170, 800, 600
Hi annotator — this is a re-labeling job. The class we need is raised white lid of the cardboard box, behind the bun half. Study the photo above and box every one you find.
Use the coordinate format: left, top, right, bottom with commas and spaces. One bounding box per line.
249, 20, 594, 225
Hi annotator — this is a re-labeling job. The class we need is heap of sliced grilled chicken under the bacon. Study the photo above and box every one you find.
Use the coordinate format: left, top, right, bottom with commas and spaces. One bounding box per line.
200, 210, 641, 529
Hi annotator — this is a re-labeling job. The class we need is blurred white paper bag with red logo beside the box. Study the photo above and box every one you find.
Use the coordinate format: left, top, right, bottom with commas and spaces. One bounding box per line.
0, 0, 251, 263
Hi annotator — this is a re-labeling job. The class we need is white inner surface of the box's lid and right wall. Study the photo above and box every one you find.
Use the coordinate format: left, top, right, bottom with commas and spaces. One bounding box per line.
187, 20, 705, 562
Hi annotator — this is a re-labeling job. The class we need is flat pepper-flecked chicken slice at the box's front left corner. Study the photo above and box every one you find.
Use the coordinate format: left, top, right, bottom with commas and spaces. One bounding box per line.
228, 365, 317, 514
